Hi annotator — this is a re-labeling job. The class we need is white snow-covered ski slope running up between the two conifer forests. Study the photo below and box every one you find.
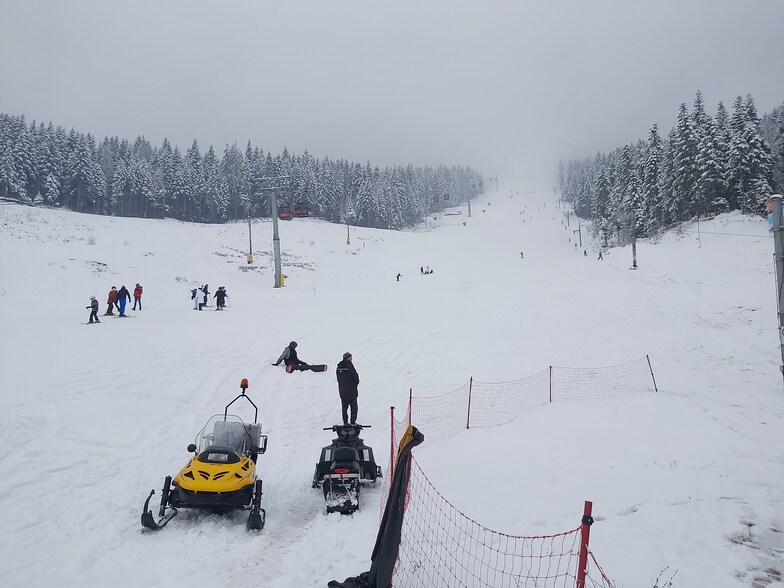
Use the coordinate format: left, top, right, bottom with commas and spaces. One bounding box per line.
0, 191, 784, 588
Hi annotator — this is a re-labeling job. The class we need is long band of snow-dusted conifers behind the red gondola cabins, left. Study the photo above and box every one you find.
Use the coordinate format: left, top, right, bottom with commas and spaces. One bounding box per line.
0, 114, 483, 229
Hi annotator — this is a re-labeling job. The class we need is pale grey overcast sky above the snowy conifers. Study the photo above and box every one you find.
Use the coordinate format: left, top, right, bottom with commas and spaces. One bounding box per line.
0, 0, 784, 185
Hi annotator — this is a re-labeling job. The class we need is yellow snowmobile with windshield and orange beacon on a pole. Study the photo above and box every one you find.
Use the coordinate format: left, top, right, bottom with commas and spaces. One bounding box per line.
142, 378, 267, 530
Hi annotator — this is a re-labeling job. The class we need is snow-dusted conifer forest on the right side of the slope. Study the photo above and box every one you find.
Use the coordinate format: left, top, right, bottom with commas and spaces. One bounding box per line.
558, 92, 784, 244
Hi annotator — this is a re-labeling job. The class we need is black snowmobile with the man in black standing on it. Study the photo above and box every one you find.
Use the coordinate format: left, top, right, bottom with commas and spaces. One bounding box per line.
313, 425, 382, 514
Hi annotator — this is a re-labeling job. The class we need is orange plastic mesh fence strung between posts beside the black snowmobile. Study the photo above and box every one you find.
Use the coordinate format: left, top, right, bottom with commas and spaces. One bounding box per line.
374, 358, 655, 588
